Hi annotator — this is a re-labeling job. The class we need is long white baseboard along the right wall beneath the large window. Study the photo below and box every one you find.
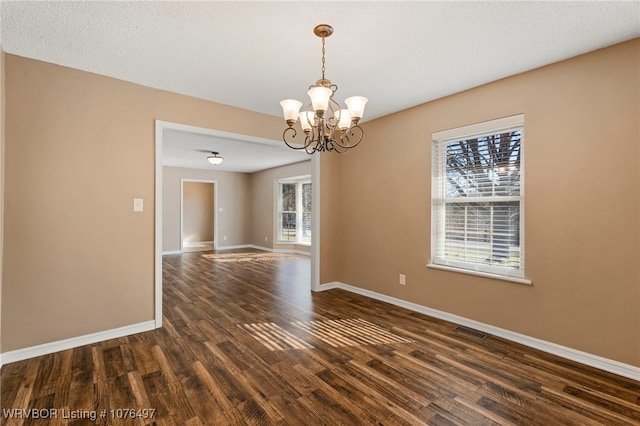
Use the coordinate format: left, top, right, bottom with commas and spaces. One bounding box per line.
318, 282, 640, 381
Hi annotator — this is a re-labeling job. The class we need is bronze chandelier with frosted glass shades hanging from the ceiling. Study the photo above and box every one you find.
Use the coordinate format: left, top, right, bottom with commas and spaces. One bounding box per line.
280, 24, 367, 154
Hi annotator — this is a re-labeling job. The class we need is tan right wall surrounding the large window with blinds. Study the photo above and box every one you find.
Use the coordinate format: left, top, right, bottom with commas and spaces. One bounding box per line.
330, 39, 640, 366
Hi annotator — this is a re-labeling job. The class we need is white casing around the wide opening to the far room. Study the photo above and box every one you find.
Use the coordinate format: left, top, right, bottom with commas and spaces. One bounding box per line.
154, 120, 322, 328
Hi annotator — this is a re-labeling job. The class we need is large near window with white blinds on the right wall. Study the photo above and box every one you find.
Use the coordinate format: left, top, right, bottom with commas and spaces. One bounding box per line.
431, 115, 526, 281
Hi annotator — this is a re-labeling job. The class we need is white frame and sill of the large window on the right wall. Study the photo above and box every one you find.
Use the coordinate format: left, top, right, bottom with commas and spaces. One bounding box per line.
427, 114, 531, 285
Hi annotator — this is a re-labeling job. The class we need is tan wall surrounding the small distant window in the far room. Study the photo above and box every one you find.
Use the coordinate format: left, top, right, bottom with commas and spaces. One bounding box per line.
251, 160, 311, 251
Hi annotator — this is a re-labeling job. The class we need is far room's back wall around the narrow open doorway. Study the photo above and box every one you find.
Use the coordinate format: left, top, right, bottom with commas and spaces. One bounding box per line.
162, 167, 251, 252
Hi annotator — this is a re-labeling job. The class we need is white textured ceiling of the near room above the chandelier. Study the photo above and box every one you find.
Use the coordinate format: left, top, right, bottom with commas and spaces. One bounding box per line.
0, 0, 640, 171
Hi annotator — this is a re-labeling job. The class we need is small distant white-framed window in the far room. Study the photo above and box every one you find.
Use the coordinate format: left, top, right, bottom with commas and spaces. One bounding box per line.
277, 176, 311, 244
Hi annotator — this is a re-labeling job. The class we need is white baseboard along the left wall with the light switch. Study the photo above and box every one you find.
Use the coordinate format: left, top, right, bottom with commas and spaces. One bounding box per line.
0, 320, 156, 366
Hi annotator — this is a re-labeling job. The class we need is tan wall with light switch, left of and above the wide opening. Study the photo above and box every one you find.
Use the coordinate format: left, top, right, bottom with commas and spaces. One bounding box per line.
2, 55, 282, 352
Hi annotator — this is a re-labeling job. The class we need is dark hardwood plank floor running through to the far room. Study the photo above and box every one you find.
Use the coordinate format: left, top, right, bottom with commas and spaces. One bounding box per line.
0, 250, 640, 426
